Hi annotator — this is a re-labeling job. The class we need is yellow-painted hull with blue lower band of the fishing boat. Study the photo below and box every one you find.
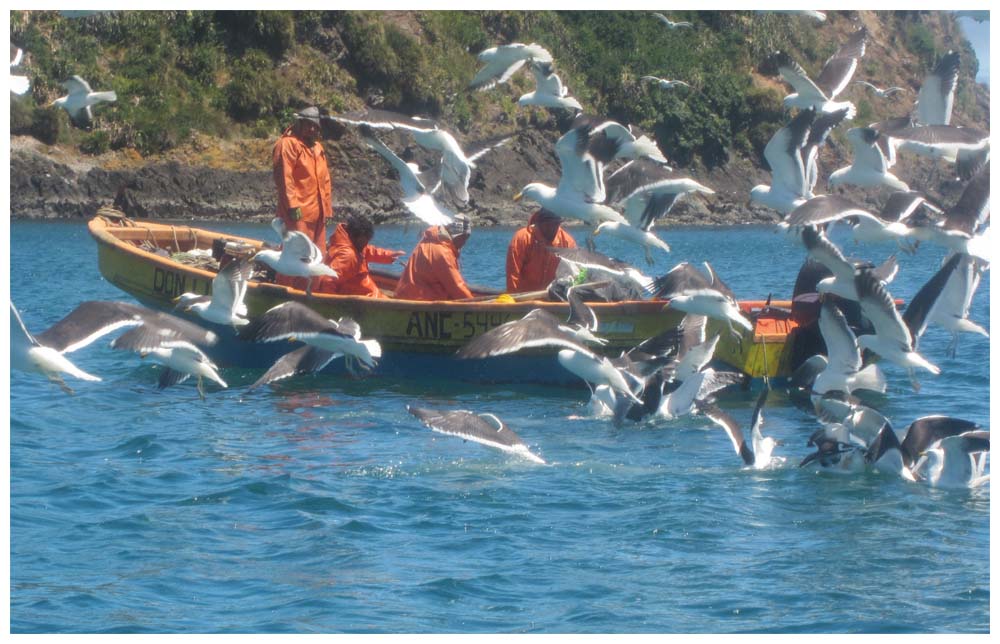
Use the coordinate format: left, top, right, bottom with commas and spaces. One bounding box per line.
88, 215, 800, 381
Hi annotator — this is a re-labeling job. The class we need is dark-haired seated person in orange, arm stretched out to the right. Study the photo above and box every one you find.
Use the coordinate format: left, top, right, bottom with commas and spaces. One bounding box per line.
316, 215, 406, 297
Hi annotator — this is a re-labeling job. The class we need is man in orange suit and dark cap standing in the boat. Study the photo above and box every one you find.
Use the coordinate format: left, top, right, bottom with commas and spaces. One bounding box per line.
273, 107, 333, 288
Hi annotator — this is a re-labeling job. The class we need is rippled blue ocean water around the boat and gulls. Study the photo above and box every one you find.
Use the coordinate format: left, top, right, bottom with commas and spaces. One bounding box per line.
10, 220, 990, 633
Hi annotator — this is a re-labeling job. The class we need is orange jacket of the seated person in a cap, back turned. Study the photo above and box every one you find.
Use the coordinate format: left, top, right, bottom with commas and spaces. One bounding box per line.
396, 226, 472, 300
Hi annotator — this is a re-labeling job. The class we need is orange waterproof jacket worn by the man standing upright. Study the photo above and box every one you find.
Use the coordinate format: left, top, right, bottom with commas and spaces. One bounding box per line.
273, 128, 333, 244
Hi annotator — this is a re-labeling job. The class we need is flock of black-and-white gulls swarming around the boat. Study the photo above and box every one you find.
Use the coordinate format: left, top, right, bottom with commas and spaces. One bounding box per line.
11, 12, 992, 487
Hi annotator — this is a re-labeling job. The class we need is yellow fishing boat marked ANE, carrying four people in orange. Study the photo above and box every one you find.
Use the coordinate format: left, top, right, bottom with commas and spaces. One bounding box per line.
88, 208, 812, 384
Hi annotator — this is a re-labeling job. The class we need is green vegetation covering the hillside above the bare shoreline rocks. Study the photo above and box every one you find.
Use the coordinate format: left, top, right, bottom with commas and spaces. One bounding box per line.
11, 11, 987, 168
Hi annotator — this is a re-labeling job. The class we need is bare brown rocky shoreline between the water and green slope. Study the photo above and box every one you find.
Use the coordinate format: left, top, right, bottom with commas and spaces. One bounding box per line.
10, 121, 976, 228
